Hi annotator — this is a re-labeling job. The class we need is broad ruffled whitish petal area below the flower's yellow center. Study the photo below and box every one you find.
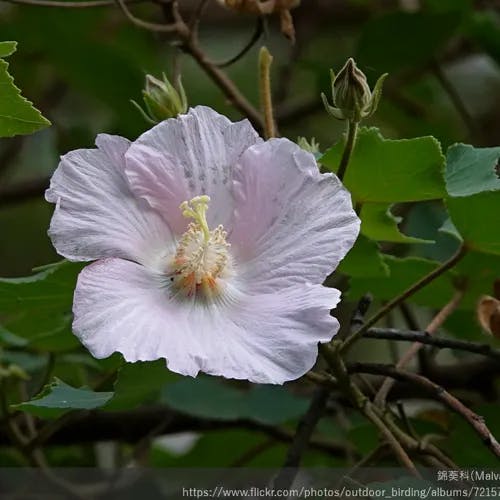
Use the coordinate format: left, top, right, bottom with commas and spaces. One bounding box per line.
73, 259, 340, 384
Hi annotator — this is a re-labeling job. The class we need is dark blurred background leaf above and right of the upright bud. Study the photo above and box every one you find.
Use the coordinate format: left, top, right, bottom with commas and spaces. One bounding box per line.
356, 12, 461, 73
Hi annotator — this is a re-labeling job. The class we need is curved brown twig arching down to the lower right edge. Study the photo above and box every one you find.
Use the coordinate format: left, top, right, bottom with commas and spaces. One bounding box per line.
347, 363, 500, 458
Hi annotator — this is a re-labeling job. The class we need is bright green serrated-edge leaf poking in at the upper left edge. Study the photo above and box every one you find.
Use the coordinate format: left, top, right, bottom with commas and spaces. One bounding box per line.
0, 42, 50, 137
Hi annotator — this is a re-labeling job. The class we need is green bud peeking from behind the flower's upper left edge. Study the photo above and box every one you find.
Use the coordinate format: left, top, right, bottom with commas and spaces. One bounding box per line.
132, 75, 188, 124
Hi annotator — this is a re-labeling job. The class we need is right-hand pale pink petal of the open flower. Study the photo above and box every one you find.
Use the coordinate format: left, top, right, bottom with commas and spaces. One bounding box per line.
229, 139, 360, 293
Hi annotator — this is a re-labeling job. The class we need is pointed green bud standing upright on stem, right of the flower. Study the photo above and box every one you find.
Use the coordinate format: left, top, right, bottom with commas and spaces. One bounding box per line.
321, 58, 387, 123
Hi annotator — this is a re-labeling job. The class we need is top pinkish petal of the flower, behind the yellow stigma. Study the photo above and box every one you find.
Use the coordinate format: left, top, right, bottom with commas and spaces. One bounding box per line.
126, 106, 260, 234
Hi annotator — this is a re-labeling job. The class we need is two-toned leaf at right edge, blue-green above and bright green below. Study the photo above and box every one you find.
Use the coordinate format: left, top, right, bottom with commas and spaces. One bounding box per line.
446, 144, 500, 255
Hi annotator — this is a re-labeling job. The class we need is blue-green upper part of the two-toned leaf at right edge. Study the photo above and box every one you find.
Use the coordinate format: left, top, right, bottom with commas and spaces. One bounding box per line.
446, 144, 500, 197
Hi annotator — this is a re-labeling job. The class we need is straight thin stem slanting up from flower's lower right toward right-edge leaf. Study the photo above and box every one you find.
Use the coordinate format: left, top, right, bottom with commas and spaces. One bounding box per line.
340, 244, 467, 352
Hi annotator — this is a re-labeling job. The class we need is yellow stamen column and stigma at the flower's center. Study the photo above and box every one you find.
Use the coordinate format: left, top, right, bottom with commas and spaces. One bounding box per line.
169, 195, 230, 300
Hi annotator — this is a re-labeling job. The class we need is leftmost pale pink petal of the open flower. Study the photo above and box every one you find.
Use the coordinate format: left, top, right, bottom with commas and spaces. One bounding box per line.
45, 135, 173, 266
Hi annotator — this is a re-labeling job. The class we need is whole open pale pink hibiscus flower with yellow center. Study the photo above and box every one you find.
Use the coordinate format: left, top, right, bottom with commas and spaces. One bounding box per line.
46, 106, 359, 384
